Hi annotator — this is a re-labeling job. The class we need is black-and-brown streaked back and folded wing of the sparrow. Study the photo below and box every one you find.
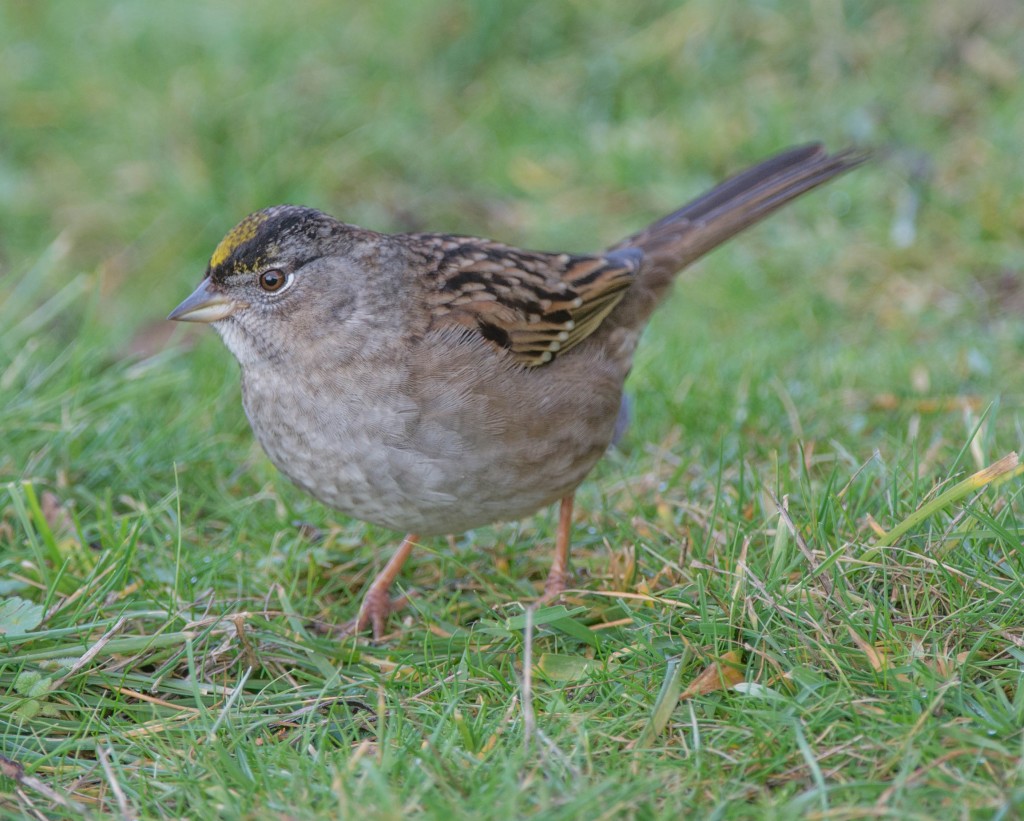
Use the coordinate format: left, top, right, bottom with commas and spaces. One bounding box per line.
417, 234, 643, 366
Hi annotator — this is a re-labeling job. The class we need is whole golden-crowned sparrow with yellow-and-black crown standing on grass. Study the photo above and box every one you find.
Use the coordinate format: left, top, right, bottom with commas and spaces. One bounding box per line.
169, 144, 863, 636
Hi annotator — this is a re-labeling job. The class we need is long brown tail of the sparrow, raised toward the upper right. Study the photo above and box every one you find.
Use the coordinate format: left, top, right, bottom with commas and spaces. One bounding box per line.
610, 143, 867, 327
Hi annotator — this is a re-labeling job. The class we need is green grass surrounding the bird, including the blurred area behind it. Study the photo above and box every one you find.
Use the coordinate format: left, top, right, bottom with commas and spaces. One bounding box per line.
0, 0, 1024, 819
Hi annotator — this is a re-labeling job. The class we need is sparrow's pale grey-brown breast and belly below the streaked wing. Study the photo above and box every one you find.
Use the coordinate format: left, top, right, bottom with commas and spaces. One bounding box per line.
243, 334, 622, 535
